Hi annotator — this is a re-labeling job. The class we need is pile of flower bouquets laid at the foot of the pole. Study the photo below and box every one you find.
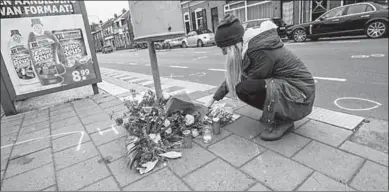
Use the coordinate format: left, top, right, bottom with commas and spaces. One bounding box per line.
111, 90, 236, 174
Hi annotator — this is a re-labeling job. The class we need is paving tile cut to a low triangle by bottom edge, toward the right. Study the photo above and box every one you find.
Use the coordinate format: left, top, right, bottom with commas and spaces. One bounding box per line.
297, 172, 354, 191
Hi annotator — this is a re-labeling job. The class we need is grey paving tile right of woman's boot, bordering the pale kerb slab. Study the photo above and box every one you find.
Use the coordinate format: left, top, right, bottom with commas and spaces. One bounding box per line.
295, 121, 353, 147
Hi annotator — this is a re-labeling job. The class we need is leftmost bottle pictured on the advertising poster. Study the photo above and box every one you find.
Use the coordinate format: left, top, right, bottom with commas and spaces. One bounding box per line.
8, 29, 39, 85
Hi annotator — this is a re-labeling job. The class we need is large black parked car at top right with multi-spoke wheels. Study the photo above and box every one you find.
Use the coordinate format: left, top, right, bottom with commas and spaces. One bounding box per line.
287, 2, 388, 42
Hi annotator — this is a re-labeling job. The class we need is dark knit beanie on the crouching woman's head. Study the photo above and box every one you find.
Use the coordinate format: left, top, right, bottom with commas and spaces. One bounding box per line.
215, 14, 244, 47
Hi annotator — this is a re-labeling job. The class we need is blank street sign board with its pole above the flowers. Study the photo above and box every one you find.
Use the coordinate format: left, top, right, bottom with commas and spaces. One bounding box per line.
129, 1, 185, 99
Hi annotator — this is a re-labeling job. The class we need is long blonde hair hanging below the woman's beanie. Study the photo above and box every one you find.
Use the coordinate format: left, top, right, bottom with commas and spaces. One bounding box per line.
223, 43, 242, 99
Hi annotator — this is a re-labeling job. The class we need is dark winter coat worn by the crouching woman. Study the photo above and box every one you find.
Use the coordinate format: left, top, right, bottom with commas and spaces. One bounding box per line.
213, 26, 315, 125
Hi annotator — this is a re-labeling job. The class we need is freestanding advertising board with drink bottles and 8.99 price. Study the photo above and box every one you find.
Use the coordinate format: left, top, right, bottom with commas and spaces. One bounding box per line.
0, 0, 101, 115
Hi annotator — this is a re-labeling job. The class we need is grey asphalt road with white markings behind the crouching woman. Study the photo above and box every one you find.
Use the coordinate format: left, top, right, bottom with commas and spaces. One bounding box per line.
98, 39, 388, 120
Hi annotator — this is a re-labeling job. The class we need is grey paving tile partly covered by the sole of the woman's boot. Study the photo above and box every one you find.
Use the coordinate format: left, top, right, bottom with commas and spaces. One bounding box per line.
254, 133, 311, 157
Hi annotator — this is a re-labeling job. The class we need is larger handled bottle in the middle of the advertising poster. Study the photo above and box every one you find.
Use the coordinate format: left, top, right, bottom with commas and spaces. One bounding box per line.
28, 19, 66, 85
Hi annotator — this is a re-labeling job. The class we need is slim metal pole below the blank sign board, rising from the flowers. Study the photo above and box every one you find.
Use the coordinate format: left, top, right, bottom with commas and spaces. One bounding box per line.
147, 41, 162, 99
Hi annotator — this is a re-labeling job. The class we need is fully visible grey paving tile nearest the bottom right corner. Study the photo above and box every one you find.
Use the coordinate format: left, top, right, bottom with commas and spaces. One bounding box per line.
293, 141, 363, 183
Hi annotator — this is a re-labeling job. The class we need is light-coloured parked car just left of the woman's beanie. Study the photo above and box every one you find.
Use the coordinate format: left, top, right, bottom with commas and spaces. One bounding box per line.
181, 29, 216, 48
